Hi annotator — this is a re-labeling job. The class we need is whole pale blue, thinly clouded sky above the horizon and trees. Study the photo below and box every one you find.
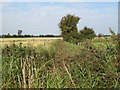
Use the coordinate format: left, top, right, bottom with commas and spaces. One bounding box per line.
0, 0, 118, 35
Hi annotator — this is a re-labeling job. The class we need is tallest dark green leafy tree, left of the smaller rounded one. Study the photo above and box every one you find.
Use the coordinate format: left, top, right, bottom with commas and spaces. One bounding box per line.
58, 14, 80, 43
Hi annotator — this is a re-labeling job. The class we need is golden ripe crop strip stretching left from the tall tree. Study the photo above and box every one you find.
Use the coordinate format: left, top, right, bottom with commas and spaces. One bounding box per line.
0, 37, 62, 47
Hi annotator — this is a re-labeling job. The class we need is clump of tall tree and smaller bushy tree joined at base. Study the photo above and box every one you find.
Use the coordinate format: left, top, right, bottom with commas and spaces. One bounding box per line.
59, 14, 96, 44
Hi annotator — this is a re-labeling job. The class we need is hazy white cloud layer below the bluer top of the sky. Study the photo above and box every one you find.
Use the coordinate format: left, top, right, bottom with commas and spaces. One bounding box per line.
3, 2, 118, 35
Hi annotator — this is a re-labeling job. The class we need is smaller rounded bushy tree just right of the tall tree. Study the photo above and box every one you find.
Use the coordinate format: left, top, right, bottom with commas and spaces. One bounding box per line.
80, 27, 96, 39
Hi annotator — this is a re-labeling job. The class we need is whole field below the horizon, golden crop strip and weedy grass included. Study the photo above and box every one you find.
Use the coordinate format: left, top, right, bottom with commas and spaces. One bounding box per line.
1, 38, 120, 88
